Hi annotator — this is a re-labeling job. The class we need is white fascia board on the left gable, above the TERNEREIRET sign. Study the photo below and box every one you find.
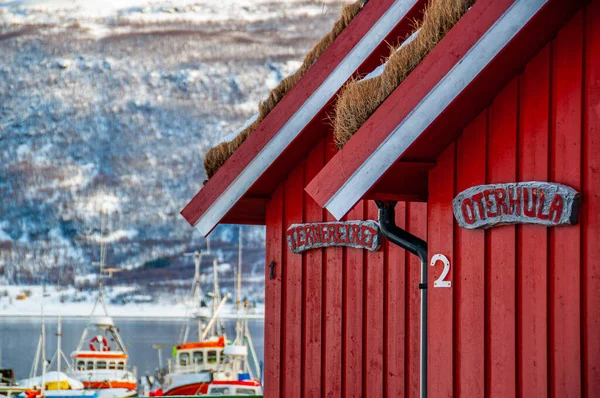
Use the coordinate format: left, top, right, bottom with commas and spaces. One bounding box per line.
194, 0, 417, 236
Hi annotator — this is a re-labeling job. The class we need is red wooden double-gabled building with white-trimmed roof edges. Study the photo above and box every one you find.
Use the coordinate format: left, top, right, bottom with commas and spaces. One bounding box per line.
182, 0, 600, 398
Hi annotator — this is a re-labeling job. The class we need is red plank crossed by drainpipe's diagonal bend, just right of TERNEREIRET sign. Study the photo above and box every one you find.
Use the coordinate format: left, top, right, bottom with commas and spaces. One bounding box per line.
384, 202, 407, 397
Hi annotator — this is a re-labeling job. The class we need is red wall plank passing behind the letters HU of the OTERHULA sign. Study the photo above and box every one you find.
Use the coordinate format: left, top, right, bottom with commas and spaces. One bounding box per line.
517, 45, 551, 398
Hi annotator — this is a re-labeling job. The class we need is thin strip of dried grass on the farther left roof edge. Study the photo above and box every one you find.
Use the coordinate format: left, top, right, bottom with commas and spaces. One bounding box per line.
204, 0, 363, 178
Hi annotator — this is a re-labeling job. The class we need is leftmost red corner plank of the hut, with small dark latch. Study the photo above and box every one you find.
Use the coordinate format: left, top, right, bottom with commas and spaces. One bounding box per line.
264, 187, 285, 398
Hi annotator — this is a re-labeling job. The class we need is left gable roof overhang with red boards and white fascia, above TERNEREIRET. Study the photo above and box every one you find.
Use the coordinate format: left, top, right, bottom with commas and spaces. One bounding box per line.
181, 0, 425, 235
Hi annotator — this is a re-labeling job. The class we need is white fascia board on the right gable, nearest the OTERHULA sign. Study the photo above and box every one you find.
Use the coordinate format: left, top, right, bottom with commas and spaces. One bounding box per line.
325, 0, 548, 220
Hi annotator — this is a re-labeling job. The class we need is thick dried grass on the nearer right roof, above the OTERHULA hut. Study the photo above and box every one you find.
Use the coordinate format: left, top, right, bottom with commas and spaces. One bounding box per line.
334, 0, 476, 148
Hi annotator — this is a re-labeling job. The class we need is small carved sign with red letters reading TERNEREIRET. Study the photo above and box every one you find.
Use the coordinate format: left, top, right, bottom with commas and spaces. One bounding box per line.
286, 221, 381, 253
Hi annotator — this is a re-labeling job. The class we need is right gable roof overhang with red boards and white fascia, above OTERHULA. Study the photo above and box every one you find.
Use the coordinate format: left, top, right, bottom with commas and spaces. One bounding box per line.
306, 0, 585, 219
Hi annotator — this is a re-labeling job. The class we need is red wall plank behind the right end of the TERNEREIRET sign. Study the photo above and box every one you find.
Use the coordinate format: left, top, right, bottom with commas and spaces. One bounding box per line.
364, 201, 384, 398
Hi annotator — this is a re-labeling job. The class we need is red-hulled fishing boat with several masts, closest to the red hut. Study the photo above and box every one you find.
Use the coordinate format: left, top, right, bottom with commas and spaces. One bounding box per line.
151, 230, 262, 396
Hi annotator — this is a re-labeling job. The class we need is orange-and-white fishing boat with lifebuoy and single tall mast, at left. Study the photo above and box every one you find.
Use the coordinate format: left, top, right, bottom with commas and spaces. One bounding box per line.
71, 218, 137, 398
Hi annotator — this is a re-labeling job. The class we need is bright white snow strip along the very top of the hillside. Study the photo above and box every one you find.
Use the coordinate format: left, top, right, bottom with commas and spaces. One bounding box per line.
0, 0, 335, 33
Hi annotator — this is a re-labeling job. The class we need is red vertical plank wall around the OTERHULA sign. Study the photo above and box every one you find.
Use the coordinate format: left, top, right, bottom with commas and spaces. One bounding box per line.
428, 7, 600, 397
